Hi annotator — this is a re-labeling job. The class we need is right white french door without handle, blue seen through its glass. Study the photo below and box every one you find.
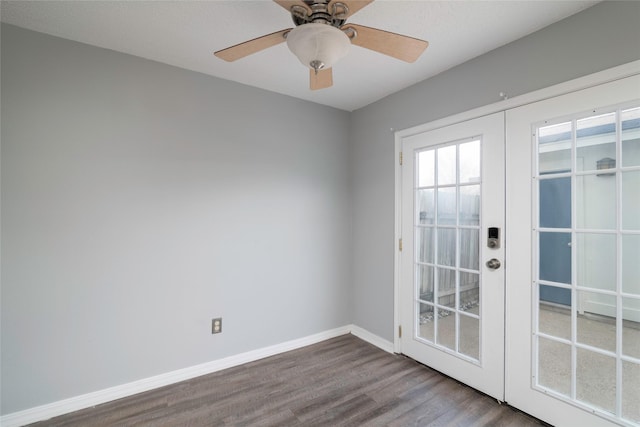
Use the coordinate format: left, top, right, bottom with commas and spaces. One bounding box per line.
506, 76, 640, 426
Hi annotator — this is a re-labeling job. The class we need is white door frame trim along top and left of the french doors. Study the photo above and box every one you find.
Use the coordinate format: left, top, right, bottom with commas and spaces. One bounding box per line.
393, 60, 640, 353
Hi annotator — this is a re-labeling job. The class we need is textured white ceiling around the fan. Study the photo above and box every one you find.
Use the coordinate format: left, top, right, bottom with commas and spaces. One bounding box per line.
0, 0, 598, 111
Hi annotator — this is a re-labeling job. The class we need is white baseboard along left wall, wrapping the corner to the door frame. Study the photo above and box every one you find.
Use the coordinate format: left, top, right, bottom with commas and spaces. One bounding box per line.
0, 325, 393, 427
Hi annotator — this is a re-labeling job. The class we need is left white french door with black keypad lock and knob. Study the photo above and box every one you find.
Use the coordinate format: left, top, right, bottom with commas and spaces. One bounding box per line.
400, 113, 504, 400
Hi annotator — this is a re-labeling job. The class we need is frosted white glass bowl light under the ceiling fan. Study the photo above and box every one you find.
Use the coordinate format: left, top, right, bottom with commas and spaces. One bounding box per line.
287, 23, 351, 72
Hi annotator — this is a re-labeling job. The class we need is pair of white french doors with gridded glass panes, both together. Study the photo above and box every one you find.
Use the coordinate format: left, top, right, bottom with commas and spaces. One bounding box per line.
397, 75, 640, 426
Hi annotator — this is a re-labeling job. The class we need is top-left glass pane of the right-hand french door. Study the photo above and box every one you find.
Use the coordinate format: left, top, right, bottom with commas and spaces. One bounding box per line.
538, 122, 573, 175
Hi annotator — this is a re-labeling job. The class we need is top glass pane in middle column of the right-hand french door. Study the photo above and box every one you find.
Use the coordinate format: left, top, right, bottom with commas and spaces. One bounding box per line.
576, 113, 616, 175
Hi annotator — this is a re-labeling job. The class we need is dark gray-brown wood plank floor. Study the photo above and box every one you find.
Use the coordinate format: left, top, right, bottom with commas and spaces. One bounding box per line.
32, 335, 544, 427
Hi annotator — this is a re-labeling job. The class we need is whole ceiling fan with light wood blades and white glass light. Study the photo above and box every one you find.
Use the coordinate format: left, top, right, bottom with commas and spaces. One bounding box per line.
214, 0, 429, 90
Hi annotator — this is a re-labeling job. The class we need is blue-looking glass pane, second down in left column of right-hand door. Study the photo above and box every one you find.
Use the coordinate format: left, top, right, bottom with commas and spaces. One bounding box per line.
539, 177, 571, 228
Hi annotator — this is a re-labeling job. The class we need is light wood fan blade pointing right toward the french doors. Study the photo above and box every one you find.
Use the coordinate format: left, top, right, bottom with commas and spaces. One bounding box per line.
342, 24, 429, 62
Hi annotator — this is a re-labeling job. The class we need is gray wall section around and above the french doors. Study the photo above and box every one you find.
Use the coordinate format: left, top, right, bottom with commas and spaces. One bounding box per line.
350, 2, 640, 341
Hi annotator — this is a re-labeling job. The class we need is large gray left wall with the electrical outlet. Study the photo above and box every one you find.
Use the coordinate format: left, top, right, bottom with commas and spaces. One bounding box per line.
1, 25, 351, 414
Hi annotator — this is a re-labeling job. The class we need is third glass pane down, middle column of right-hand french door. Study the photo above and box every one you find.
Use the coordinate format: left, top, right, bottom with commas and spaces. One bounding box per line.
575, 233, 617, 291
